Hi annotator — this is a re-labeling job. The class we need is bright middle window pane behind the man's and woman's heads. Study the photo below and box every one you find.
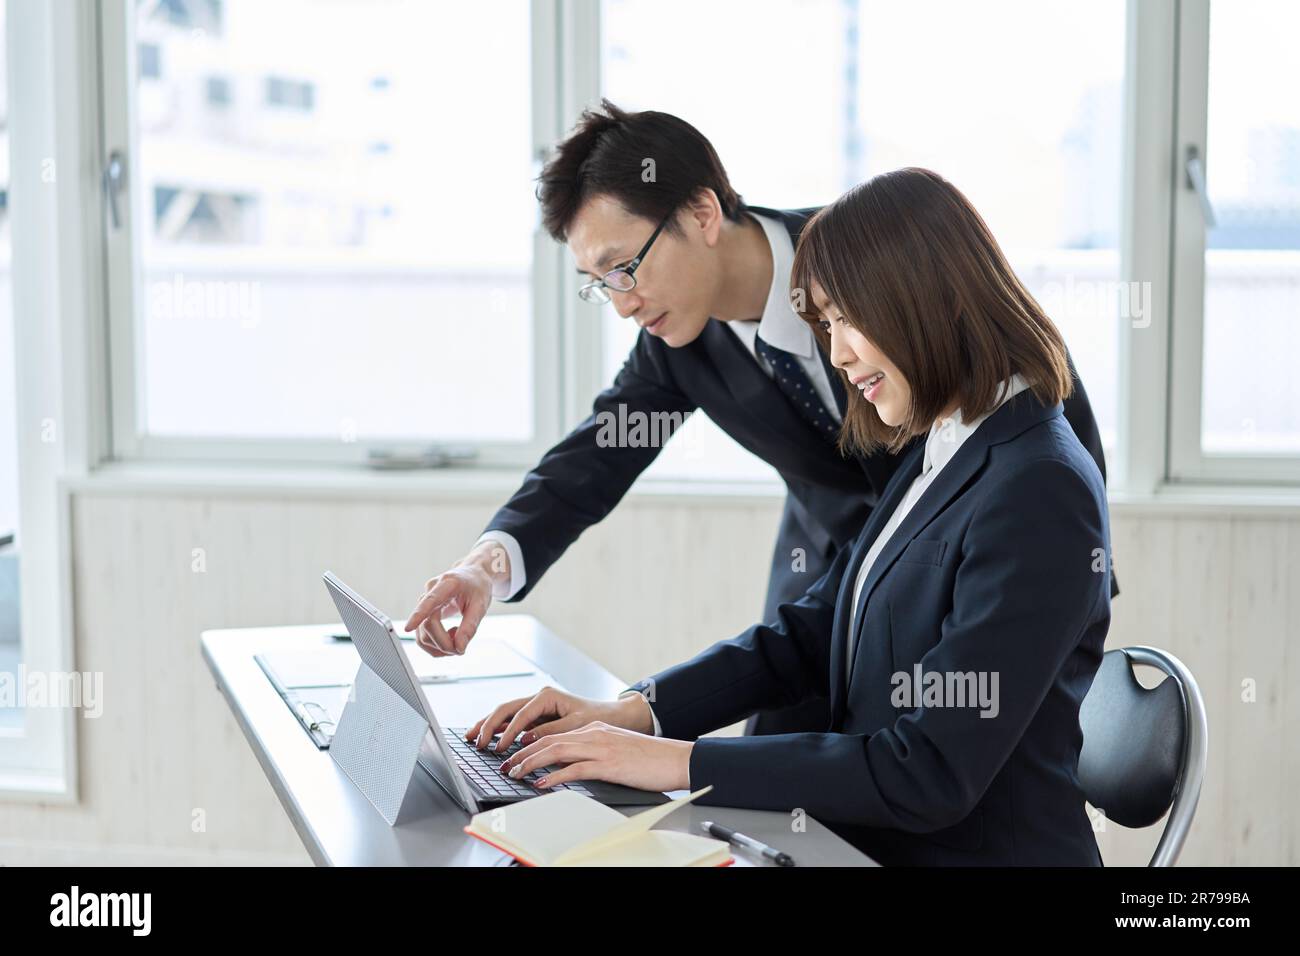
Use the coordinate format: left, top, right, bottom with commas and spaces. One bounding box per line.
603, 0, 1118, 477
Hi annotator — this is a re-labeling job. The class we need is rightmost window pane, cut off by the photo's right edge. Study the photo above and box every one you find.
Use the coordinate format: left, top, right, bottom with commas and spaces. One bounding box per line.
1201, 0, 1300, 455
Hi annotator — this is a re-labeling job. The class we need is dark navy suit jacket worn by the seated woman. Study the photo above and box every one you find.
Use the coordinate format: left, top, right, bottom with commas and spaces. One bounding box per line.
626, 392, 1110, 866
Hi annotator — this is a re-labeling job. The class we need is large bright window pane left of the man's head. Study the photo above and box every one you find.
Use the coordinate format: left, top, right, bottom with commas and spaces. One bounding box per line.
135, 0, 537, 442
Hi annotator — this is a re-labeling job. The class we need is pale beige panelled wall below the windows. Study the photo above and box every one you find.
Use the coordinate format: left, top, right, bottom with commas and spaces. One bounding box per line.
0, 485, 1300, 865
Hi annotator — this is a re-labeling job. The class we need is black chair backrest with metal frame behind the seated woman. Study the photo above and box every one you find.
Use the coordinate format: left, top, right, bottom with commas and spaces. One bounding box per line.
1079, 646, 1209, 866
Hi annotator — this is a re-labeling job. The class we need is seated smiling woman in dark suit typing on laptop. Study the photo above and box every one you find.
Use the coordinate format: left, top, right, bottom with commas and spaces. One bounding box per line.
469, 169, 1110, 865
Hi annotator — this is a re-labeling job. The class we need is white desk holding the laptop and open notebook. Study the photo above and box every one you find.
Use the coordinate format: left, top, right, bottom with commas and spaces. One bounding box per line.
202, 614, 875, 866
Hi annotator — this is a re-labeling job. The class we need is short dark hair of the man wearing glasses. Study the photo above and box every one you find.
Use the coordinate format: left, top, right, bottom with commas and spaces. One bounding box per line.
537, 100, 745, 242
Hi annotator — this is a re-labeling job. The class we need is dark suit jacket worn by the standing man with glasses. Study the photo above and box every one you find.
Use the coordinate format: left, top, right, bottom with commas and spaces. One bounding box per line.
488, 207, 1118, 732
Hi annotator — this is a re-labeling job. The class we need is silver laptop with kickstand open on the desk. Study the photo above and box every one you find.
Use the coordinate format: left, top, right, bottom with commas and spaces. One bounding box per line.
324, 571, 668, 813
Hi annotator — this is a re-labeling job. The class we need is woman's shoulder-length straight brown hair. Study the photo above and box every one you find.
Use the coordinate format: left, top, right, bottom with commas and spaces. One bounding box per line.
790, 168, 1073, 453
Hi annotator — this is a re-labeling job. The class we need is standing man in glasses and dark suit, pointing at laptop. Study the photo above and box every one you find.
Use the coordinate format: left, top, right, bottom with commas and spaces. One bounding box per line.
407, 100, 1105, 734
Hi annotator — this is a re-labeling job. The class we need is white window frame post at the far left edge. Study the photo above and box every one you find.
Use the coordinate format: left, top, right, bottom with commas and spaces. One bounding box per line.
0, 3, 107, 804
